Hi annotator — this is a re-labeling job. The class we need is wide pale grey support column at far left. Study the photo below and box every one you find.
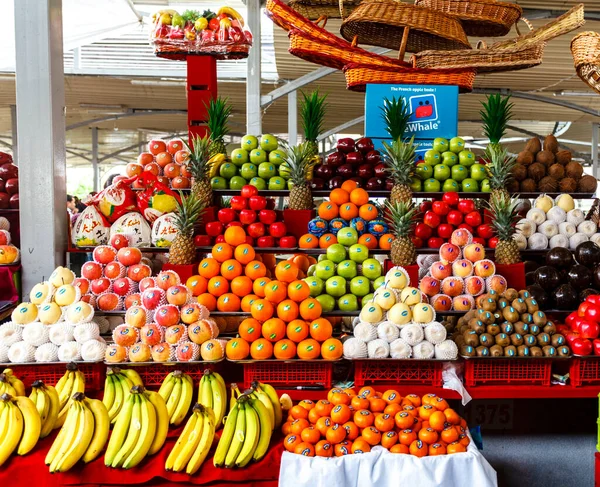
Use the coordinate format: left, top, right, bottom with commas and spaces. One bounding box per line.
14, 0, 68, 293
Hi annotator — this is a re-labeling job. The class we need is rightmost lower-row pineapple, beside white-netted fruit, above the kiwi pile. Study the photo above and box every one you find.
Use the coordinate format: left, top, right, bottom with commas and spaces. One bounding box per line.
489, 191, 521, 264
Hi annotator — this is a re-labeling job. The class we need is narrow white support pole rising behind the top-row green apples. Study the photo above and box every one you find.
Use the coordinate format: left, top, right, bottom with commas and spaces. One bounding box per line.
246, 0, 262, 135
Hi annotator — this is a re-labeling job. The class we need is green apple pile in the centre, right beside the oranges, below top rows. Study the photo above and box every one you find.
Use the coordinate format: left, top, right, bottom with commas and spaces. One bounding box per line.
304, 233, 385, 312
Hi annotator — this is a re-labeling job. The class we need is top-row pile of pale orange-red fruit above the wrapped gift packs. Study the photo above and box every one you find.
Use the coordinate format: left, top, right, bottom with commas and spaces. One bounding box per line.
125, 139, 192, 189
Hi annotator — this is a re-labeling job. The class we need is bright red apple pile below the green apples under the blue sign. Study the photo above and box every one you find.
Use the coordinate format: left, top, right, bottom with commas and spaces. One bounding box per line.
413, 192, 498, 249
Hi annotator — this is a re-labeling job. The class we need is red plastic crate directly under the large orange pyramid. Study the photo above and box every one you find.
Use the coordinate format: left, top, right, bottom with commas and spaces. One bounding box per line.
243, 360, 333, 389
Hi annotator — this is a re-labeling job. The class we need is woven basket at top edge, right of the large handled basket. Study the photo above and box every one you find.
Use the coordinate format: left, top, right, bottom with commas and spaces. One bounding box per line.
415, 0, 523, 37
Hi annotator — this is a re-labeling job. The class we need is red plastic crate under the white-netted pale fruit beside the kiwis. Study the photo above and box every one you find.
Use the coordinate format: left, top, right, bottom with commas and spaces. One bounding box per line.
353, 359, 443, 386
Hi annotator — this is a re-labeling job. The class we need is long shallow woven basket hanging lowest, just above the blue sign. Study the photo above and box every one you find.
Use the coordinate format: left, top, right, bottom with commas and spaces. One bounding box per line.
344, 64, 475, 93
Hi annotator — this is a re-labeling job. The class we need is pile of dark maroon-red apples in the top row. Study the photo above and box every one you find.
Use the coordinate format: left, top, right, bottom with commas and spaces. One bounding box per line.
311, 137, 386, 190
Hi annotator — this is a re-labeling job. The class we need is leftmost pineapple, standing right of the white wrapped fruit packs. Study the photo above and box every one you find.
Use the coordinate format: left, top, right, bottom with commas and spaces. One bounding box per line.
169, 192, 204, 265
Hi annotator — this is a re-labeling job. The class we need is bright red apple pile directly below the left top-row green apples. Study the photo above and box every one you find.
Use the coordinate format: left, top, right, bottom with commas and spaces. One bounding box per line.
194, 185, 297, 248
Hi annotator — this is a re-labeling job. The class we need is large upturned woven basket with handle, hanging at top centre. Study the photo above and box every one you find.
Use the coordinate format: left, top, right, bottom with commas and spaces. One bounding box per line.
340, 0, 471, 54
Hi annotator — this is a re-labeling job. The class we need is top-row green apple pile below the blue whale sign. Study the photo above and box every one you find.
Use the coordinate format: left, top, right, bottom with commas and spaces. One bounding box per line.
411, 137, 491, 193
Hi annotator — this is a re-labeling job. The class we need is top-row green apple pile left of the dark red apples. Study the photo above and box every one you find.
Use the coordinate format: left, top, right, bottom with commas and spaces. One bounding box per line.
210, 134, 289, 190
